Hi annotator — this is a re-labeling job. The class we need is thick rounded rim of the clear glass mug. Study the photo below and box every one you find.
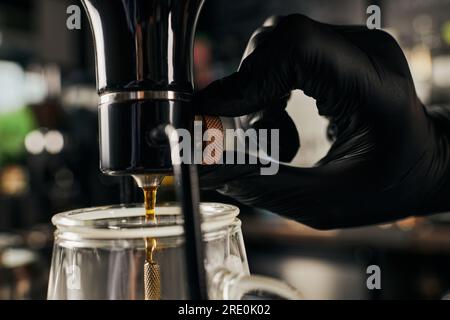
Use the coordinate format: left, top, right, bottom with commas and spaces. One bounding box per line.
52, 202, 239, 240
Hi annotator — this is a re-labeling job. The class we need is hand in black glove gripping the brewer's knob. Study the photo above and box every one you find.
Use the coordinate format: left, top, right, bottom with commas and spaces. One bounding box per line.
195, 15, 450, 229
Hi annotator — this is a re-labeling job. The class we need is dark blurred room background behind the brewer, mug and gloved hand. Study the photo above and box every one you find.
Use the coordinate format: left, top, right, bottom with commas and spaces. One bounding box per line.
0, 0, 450, 299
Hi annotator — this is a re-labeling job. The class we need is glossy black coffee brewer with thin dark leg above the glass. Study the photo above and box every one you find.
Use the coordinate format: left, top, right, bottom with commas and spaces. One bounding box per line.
82, 0, 207, 299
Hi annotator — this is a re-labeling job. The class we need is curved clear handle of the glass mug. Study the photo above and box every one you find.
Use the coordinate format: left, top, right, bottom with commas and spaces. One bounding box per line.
210, 269, 303, 300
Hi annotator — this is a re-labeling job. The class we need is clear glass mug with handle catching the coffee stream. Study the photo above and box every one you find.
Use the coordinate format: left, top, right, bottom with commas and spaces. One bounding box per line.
48, 203, 301, 300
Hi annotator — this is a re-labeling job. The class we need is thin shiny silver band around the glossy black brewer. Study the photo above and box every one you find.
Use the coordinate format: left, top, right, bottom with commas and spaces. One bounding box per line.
99, 90, 192, 104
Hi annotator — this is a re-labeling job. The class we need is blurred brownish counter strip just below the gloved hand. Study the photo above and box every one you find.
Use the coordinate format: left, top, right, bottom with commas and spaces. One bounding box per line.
243, 214, 450, 253
